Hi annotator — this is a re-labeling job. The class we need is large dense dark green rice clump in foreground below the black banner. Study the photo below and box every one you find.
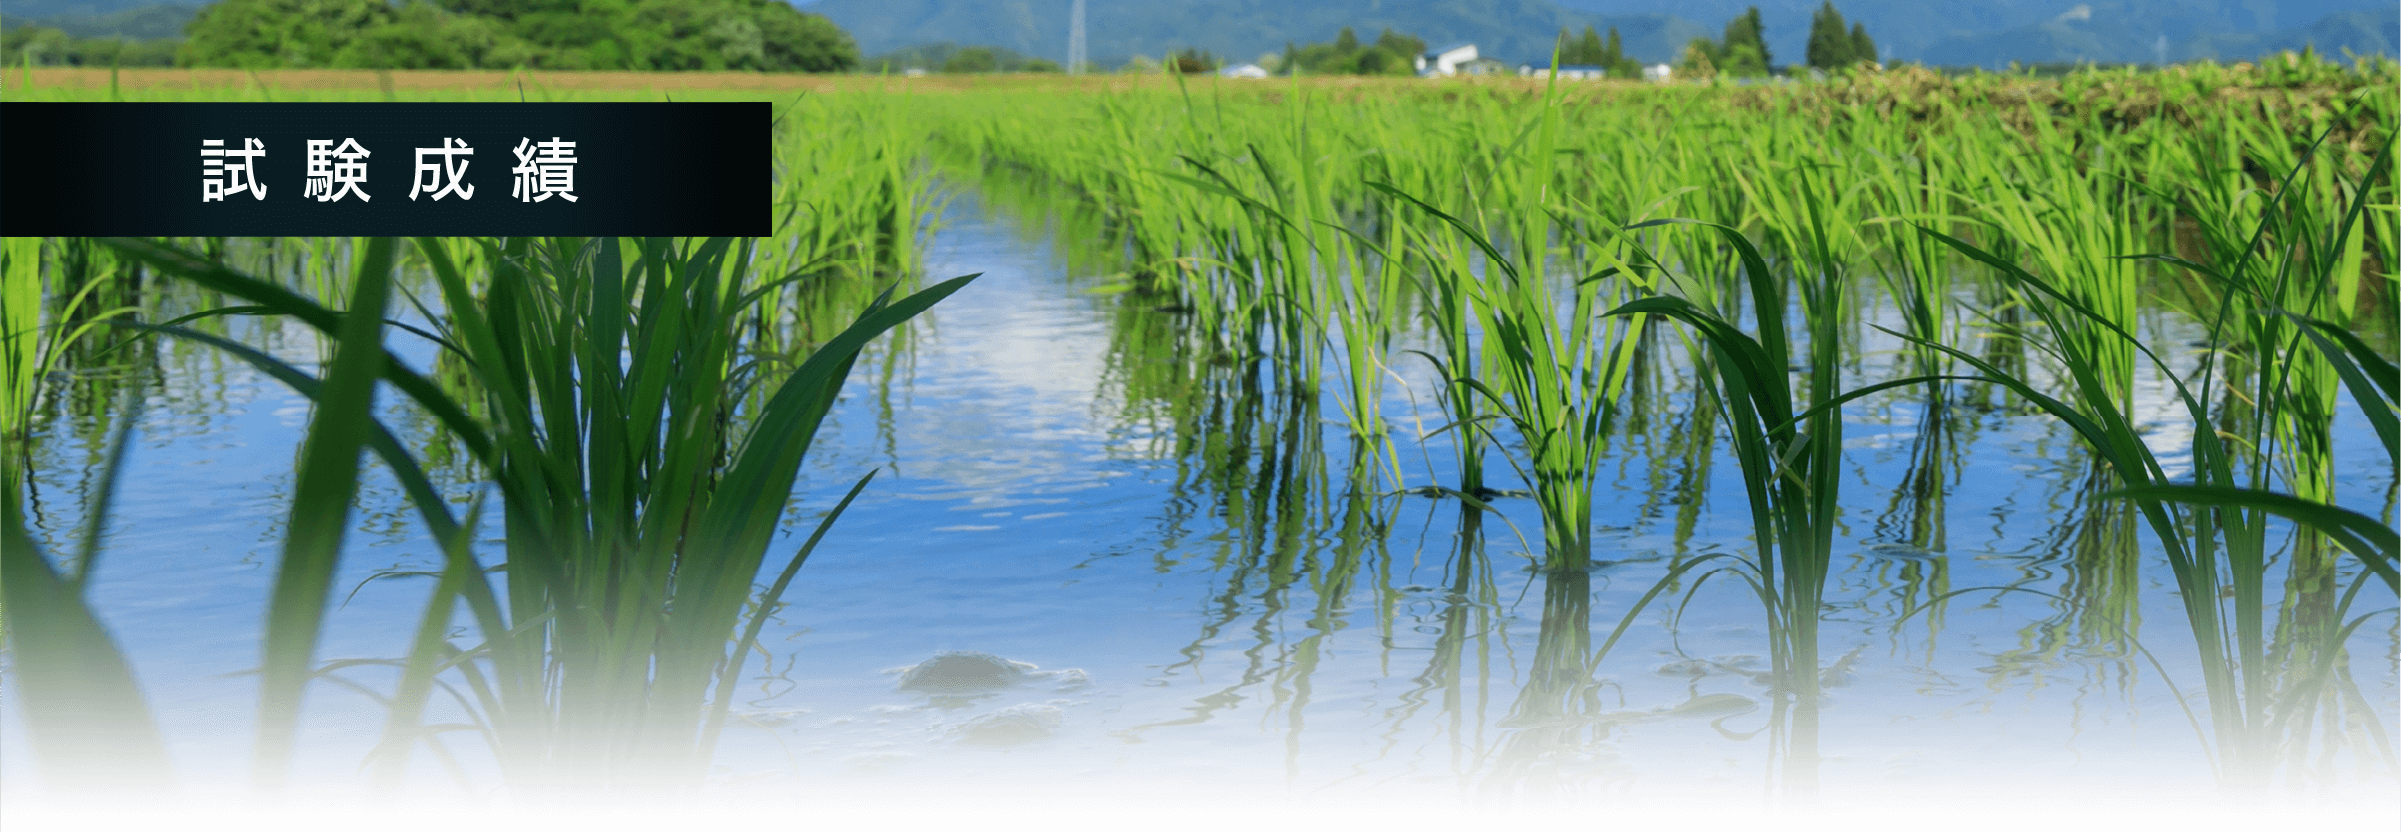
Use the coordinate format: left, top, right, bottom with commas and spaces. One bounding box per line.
379, 240, 970, 790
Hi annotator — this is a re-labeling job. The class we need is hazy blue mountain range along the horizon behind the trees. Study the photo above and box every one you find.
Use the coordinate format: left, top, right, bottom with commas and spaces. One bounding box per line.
14, 0, 2401, 70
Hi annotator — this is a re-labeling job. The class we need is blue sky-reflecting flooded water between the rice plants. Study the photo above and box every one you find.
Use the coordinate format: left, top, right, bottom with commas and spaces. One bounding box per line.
0, 192, 2401, 828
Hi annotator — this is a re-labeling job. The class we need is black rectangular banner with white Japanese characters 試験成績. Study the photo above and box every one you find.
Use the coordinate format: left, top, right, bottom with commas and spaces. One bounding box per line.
0, 103, 773, 238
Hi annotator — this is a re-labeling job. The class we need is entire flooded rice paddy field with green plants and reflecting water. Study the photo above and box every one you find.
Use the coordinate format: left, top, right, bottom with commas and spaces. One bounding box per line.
0, 58, 2401, 831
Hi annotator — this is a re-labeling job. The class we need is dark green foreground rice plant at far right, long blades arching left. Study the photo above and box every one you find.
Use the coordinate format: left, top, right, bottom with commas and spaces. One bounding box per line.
1926, 118, 2389, 787
